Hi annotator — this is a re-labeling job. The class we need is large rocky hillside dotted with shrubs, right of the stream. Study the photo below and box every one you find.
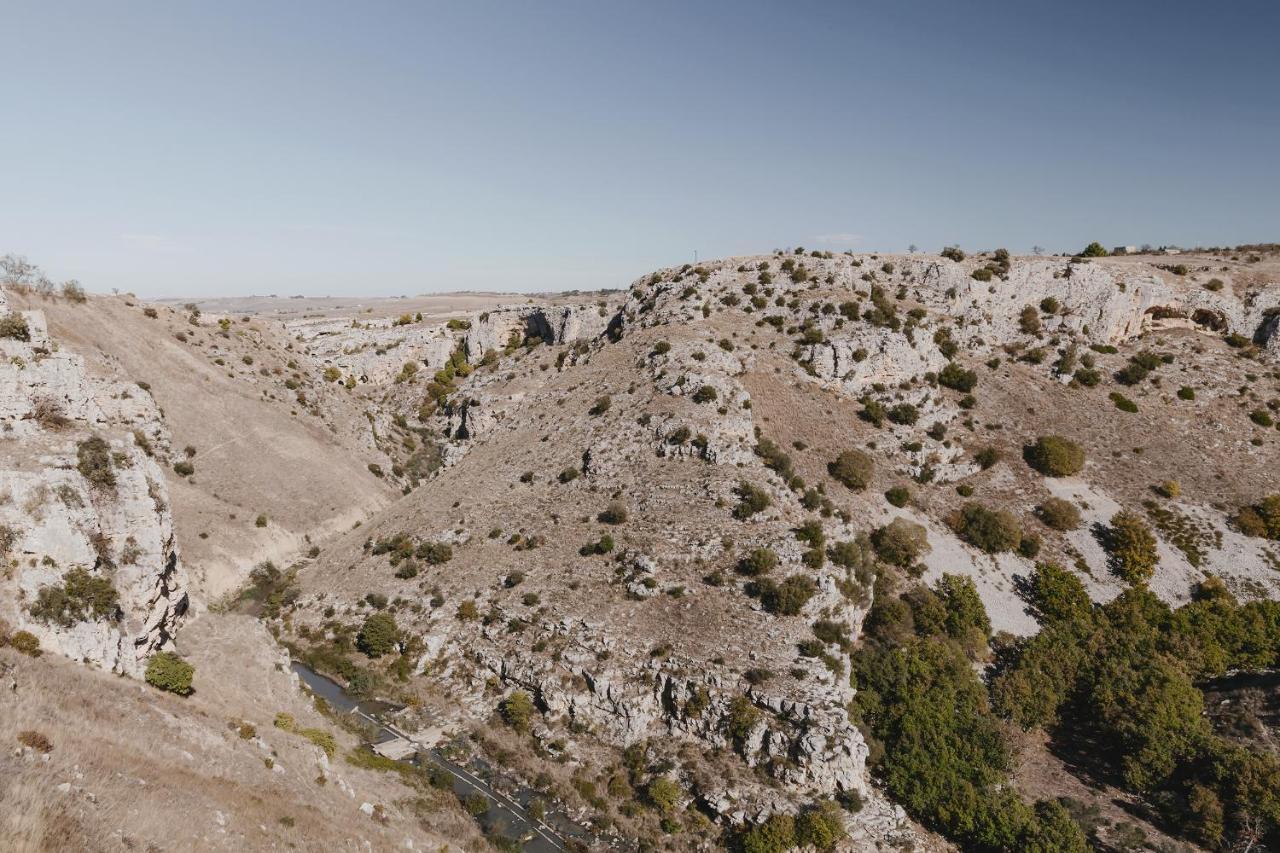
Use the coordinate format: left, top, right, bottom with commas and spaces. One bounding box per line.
282, 244, 1280, 844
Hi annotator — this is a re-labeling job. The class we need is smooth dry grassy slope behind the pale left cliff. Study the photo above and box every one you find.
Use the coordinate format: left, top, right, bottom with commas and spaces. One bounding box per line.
13, 289, 394, 598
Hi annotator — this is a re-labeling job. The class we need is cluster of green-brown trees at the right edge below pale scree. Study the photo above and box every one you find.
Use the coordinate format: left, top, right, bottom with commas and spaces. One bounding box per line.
991, 564, 1280, 847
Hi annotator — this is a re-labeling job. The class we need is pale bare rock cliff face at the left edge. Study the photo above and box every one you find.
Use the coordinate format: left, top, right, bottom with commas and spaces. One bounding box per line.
0, 289, 189, 676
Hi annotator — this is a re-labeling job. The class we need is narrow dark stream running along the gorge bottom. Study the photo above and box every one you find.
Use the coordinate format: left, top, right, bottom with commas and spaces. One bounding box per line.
292, 661, 593, 853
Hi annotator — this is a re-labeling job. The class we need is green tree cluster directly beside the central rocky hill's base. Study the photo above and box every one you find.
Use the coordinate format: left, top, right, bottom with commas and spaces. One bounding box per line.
854, 575, 1088, 853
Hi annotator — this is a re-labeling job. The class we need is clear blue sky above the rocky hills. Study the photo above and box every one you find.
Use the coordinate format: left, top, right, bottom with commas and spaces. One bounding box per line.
0, 0, 1280, 296
